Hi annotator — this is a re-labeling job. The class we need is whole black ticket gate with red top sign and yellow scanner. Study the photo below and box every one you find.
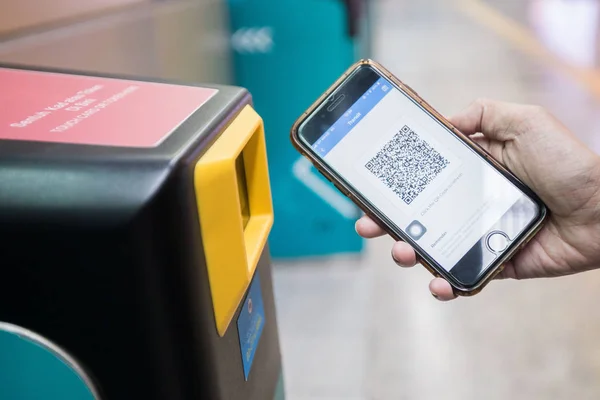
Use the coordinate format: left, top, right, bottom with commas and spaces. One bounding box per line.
0, 66, 283, 400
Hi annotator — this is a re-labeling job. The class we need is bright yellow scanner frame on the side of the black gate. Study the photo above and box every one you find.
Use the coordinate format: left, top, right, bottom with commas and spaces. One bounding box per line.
194, 106, 273, 336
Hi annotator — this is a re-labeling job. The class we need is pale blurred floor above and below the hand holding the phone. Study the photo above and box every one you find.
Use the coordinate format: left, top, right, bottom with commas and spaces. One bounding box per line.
274, 0, 600, 400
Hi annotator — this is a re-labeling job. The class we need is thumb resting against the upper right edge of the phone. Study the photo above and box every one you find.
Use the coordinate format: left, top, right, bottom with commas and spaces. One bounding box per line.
450, 99, 527, 142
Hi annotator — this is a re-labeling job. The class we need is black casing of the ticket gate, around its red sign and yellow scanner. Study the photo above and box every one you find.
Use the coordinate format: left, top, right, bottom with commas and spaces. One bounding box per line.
0, 66, 281, 400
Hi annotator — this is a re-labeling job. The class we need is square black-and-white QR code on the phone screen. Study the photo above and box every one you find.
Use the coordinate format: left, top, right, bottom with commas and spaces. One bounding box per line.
365, 125, 450, 204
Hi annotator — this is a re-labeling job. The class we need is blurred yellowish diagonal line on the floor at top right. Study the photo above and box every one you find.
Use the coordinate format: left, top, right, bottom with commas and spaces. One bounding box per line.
455, 0, 600, 99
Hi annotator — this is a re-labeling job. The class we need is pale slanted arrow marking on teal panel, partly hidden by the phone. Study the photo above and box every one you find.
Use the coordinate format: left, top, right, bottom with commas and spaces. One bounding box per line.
292, 157, 359, 219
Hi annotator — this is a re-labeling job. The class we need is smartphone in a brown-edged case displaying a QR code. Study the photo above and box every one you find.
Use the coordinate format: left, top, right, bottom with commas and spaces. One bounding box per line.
291, 60, 548, 295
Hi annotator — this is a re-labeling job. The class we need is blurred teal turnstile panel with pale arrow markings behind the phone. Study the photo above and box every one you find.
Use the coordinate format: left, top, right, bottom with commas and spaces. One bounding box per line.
229, 0, 368, 258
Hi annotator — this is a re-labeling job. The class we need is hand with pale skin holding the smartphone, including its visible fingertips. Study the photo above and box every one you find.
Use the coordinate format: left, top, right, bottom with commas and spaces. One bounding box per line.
356, 100, 600, 301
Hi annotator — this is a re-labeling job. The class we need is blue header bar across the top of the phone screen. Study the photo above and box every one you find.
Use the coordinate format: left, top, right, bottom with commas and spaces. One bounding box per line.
312, 78, 392, 157
